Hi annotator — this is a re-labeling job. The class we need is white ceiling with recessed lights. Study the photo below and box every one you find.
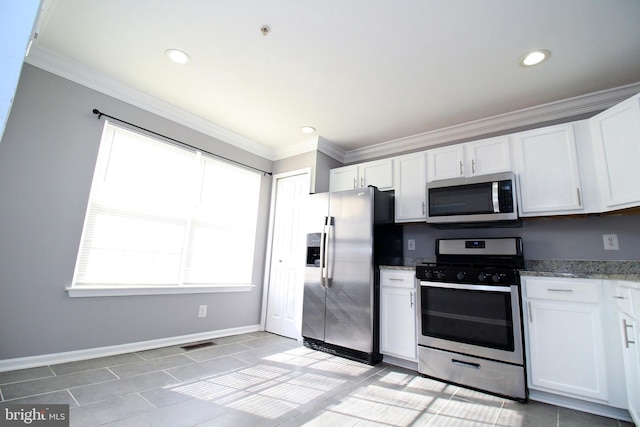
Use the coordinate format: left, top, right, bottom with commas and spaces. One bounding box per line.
27, 0, 640, 160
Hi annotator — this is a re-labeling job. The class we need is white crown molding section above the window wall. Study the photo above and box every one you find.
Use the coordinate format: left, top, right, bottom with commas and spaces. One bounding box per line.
25, 45, 274, 161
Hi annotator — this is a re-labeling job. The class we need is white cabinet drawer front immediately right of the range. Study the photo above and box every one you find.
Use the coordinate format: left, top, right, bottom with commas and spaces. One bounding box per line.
523, 278, 602, 304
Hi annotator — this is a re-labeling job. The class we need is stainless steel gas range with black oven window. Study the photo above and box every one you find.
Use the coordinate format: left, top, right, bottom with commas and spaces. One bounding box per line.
416, 237, 527, 401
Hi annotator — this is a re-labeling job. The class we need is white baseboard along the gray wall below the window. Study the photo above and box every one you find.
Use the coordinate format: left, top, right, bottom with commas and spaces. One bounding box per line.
0, 325, 263, 372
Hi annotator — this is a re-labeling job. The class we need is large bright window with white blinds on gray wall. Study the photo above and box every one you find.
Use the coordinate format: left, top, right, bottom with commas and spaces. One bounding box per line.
69, 122, 260, 296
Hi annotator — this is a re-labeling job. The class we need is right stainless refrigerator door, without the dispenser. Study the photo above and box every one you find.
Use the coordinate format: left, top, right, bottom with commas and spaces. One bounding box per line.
325, 188, 374, 353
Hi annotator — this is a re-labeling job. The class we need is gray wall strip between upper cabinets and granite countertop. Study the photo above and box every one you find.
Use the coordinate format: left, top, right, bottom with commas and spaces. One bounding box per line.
403, 215, 640, 261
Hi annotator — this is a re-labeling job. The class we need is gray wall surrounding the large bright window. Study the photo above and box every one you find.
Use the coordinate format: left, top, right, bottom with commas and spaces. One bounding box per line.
0, 65, 272, 359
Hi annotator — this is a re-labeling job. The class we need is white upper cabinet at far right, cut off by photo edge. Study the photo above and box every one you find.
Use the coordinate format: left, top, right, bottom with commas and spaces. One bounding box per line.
589, 94, 640, 211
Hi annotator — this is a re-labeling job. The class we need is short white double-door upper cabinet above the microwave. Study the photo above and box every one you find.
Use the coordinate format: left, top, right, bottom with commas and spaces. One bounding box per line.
427, 136, 511, 182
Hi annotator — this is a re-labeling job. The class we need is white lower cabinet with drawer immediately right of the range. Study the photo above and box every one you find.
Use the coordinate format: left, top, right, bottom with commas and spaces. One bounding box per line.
522, 277, 609, 404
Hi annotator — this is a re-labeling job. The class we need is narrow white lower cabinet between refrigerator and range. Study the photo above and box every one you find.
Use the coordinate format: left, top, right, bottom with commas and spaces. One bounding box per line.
380, 269, 418, 362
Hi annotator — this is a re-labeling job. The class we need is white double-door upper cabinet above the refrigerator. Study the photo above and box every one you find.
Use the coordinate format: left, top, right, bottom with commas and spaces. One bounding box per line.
329, 159, 394, 191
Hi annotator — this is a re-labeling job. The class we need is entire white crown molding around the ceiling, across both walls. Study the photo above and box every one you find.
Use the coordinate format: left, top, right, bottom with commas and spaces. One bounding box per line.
25, 46, 640, 164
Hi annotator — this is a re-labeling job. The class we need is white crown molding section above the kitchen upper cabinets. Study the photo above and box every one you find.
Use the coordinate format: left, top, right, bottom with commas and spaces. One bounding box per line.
343, 82, 640, 164
